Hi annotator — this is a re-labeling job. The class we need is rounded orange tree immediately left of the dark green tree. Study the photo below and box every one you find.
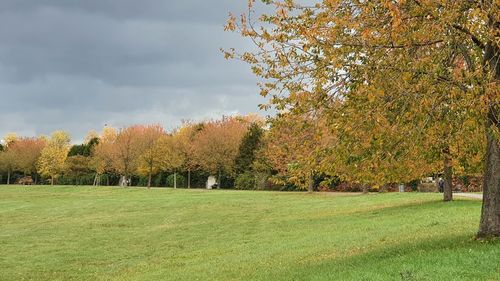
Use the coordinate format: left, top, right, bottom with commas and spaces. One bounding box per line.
193, 117, 248, 188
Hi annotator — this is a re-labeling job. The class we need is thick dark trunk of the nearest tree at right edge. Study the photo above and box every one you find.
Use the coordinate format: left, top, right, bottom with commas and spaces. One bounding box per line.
477, 40, 500, 237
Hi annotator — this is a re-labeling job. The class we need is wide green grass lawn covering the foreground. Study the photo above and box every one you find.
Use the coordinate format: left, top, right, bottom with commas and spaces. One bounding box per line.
0, 186, 500, 281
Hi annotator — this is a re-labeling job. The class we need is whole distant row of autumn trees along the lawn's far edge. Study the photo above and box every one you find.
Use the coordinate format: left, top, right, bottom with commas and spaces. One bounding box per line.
0, 109, 484, 192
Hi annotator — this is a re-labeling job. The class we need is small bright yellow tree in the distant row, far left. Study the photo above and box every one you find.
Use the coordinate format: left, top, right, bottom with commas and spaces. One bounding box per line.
37, 131, 71, 185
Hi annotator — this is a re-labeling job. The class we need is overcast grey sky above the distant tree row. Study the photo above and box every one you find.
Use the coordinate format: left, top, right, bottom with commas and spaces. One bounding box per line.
0, 0, 269, 141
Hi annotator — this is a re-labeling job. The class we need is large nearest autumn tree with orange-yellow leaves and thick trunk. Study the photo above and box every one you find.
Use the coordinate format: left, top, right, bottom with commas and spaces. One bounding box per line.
226, 0, 500, 237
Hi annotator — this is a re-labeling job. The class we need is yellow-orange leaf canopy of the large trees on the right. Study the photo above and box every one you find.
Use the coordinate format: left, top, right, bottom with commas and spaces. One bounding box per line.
225, 0, 494, 187
